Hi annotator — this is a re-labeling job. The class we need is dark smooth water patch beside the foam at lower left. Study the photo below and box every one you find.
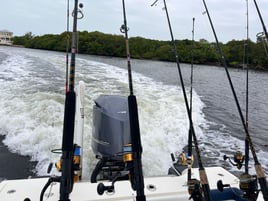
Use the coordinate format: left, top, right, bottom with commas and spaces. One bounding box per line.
0, 135, 37, 181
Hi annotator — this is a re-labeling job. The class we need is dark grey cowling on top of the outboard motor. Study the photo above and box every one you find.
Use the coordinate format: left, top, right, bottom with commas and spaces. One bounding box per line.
91, 95, 131, 161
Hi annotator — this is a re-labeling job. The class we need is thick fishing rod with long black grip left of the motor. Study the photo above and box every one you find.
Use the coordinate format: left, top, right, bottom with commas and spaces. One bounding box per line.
40, 0, 83, 201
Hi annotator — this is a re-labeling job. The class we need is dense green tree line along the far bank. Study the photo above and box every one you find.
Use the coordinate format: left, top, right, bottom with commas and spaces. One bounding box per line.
13, 31, 268, 69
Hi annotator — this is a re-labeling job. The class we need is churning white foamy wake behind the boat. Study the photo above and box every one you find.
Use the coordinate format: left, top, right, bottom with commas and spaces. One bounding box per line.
0, 48, 205, 175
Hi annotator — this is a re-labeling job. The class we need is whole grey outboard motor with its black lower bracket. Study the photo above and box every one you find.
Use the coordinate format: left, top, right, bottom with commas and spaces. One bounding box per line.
91, 95, 131, 182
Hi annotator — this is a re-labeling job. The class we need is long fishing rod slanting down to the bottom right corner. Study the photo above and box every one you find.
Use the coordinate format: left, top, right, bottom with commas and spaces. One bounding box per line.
203, 0, 268, 201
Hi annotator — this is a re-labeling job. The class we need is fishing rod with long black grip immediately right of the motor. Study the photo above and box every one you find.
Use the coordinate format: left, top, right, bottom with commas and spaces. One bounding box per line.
120, 0, 146, 201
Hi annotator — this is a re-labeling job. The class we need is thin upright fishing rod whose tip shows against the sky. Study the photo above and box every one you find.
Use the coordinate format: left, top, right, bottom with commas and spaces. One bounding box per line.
188, 18, 195, 181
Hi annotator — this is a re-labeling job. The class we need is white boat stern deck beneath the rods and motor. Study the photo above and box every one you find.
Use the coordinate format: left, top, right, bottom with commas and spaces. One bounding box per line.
0, 167, 263, 201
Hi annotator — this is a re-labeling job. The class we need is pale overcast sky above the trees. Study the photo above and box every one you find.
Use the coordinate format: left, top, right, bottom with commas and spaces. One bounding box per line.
0, 0, 268, 42
